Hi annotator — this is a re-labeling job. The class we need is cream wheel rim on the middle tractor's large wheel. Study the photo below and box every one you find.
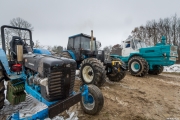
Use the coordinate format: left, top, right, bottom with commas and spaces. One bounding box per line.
82, 66, 94, 83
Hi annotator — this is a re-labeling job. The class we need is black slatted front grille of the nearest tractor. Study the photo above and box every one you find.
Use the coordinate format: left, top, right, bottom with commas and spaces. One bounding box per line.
47, 67, 75, 100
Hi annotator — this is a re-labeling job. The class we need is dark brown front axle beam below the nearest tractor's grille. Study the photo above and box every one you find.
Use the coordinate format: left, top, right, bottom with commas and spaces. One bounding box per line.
48, 92, 81, 118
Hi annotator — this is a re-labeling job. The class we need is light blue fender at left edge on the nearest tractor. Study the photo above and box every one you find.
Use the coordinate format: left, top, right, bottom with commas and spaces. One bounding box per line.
0, 48, 11, 75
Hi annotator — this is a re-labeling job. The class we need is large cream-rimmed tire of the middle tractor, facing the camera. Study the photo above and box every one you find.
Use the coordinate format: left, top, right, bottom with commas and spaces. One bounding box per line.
79, 58, 106, 87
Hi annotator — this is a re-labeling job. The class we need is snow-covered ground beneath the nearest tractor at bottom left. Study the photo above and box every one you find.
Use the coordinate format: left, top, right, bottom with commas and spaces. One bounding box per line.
0, 82, 78, 120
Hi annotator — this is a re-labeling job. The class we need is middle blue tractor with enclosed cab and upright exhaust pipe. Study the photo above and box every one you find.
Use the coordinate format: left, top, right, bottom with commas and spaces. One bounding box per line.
62, 31, 126, 87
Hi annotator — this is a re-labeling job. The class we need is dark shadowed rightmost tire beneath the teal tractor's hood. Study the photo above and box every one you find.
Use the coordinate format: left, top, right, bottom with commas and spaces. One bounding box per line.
148, 65, 164, 75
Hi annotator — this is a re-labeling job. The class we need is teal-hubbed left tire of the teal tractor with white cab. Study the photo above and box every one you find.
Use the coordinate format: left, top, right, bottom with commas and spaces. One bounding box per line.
128, 56, 149, 77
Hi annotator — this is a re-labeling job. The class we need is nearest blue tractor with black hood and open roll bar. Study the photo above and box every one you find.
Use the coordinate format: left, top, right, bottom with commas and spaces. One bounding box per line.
0, 25, 104, 120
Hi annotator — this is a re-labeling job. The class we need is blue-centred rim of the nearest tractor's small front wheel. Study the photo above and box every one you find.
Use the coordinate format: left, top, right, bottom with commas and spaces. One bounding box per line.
82, 93, 95, 110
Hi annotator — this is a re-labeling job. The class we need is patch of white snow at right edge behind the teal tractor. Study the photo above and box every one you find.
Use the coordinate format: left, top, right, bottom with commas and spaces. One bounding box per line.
163, 64, 180, 72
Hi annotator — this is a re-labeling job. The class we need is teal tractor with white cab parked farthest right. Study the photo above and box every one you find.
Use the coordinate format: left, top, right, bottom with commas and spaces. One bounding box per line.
111, 36, 178, 76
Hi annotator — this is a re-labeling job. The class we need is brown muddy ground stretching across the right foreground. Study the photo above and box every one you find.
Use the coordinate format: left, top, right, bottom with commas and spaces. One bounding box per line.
72, 73, 180, 120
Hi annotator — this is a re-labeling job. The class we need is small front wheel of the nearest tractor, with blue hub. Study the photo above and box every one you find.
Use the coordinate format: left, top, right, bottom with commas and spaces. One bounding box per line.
80, 85, 104, 115
